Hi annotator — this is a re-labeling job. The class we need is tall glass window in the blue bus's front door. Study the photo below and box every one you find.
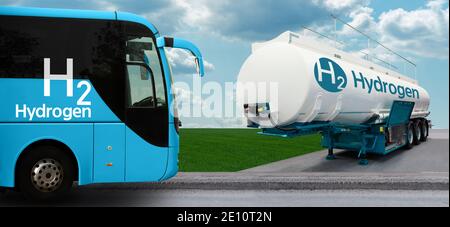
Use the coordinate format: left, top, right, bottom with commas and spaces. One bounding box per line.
126, 37, 167, 107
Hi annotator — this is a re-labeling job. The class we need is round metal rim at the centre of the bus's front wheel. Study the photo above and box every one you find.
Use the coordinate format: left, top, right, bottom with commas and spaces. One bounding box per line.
31, 159, 64, 192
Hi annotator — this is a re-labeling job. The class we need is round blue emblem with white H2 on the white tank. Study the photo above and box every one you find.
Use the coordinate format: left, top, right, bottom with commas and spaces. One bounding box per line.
314, 58, 347, 92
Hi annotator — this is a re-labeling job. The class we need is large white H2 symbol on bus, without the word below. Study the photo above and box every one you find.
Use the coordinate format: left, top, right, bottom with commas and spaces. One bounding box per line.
44, 58, 92, 106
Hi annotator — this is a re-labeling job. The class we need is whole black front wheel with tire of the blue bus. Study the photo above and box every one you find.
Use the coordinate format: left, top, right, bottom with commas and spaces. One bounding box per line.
17, 146, 75, 201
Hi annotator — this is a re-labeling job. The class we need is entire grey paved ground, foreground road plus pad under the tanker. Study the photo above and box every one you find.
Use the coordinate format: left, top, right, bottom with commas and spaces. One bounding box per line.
0, 130, 449, 207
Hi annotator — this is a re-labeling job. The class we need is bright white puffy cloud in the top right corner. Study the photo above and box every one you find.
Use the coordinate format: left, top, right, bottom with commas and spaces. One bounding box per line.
378, 1, 449, 59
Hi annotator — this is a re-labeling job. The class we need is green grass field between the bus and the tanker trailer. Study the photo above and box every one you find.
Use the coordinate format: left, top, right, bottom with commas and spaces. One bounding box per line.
180, 129, 323, 172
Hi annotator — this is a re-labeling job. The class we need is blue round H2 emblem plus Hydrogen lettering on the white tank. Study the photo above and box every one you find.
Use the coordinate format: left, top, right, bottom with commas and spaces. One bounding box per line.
314, 58, 420, 99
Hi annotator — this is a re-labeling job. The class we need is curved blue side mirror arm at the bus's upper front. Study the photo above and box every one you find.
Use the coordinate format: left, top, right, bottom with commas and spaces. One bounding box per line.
156, 37, 205, 77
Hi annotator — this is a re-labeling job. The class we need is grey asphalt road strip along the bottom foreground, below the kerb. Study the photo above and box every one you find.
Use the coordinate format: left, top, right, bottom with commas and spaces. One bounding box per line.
0, 189, 449, 207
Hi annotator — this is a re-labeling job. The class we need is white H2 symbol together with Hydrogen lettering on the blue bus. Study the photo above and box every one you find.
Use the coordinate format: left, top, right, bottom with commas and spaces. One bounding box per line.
16, 58, 92, 121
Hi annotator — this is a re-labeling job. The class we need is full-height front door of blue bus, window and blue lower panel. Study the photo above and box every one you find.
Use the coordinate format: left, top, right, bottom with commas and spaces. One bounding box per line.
125, 35, 169, 182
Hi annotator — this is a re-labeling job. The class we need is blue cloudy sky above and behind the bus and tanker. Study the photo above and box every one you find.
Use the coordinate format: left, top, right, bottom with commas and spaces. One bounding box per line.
4, 0, 449, 128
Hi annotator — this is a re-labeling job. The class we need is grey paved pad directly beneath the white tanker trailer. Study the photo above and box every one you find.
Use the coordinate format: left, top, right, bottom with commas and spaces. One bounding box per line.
241, 130, 449, 174
